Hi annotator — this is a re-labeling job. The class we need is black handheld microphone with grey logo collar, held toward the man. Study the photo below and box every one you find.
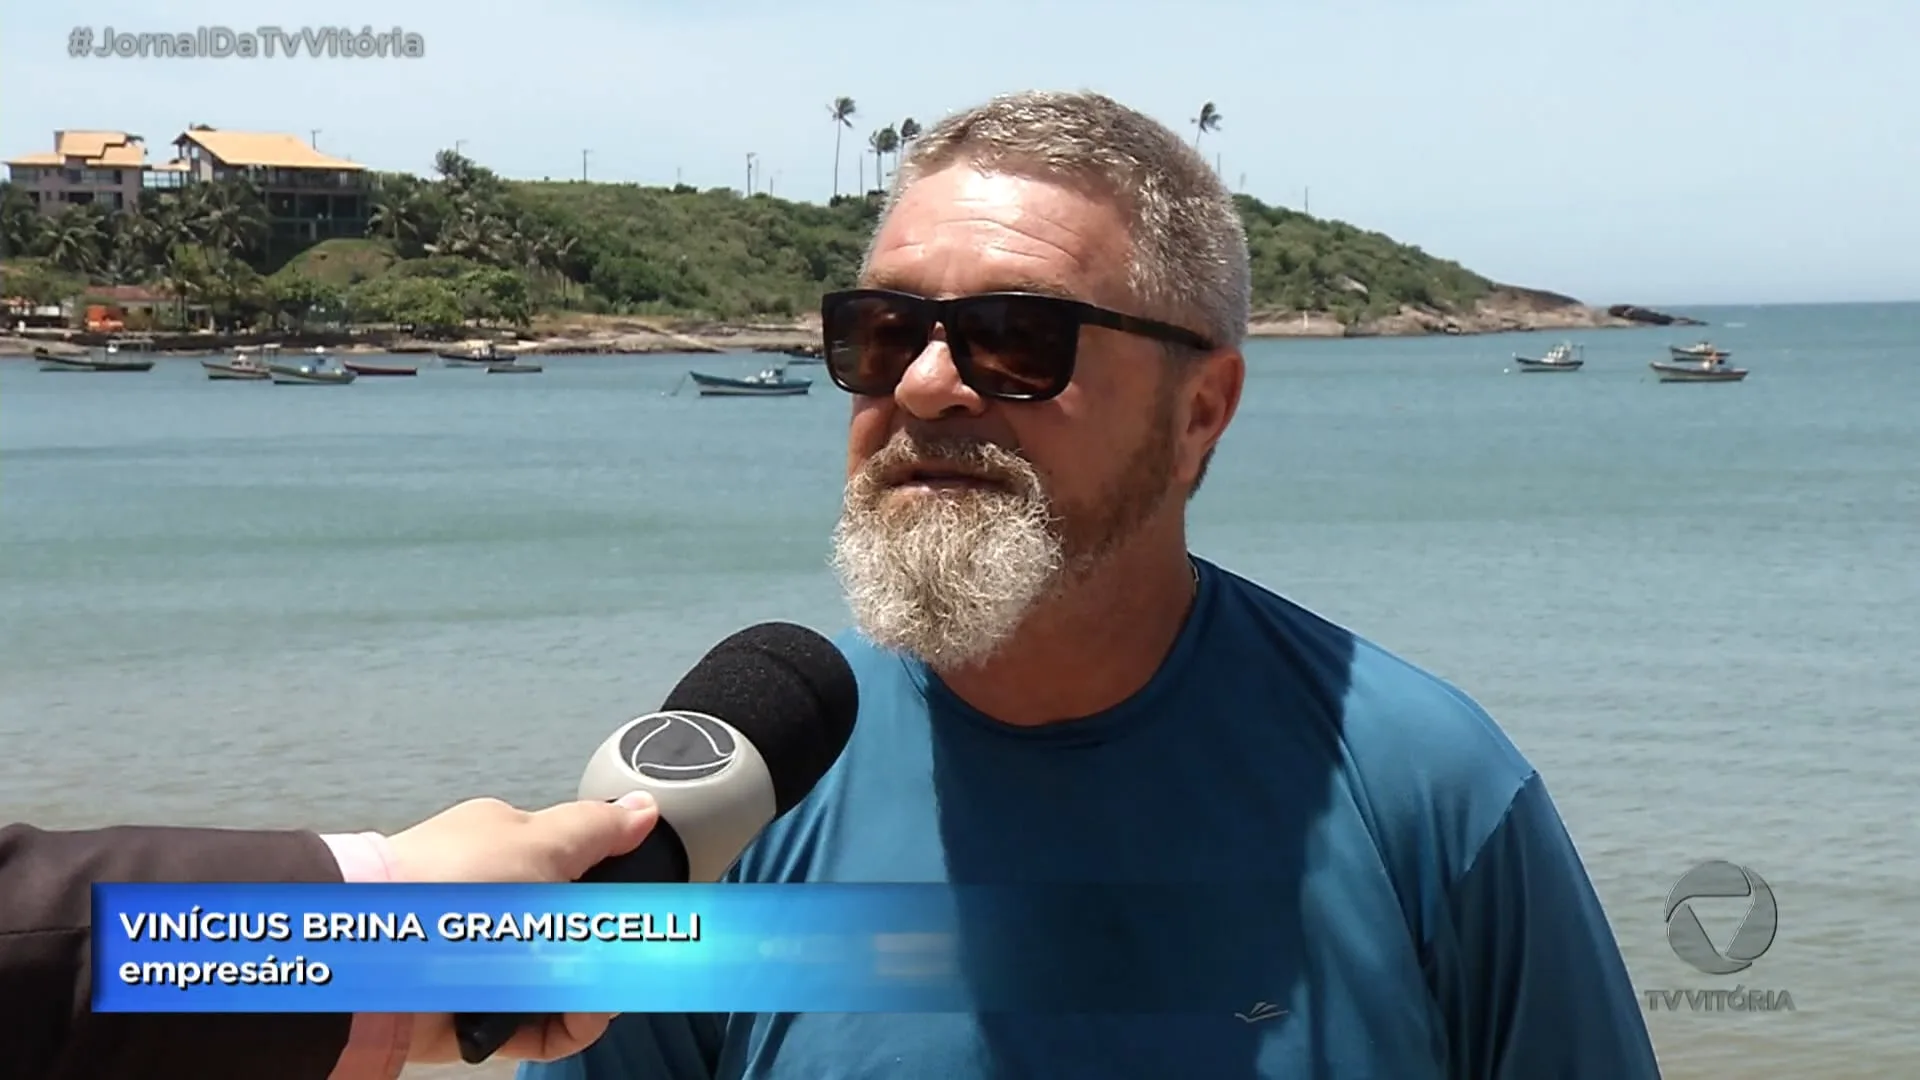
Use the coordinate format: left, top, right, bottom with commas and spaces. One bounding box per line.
453, 623, 860, 1065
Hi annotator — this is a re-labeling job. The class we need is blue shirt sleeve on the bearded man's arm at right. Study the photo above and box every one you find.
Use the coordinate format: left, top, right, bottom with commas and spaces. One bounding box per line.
1427, 774, 1661, 1080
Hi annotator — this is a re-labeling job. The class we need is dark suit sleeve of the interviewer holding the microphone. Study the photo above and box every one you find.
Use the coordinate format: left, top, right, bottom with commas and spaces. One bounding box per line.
0, 824, 353, 1080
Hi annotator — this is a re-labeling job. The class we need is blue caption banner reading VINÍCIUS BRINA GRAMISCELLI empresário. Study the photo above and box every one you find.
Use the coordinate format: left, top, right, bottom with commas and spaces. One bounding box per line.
92, 884, 1298, 1013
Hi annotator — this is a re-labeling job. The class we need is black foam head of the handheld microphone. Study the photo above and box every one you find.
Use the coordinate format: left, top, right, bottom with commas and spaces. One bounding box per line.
660, 623, 860, 813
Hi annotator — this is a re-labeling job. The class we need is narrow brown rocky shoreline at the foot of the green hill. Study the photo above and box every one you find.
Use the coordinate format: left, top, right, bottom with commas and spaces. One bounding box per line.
0, 286, 1703, 356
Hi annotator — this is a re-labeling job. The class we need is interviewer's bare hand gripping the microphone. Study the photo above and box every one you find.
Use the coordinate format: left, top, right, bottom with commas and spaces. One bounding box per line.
374, 792, 660, 1063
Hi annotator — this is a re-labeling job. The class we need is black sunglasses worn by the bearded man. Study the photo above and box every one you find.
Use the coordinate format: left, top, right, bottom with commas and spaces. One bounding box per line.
820, 288, 1213, 402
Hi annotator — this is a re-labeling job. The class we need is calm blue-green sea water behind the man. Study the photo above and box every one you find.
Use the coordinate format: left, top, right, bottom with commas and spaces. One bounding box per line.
0, 306, 1920, 1080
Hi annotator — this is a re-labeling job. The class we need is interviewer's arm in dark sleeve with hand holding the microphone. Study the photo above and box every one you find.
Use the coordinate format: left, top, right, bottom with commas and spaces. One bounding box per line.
0, 796, 657, 1080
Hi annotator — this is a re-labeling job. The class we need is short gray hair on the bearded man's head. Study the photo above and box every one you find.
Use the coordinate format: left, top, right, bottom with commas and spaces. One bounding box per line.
868, 90, 1252, 348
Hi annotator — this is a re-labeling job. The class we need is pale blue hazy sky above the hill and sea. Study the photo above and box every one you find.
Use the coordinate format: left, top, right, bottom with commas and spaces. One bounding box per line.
0, 0, 1920, 306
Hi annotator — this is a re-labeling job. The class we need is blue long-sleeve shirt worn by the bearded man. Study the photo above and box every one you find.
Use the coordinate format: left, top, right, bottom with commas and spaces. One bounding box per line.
520, 561, 1659, 1080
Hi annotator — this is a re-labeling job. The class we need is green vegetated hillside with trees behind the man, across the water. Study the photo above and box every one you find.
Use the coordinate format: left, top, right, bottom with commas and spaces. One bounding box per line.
0, 152, 1492, 331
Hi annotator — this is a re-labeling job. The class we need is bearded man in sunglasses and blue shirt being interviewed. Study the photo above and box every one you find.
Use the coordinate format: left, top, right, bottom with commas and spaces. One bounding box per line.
522, 94, 1659, 1080
